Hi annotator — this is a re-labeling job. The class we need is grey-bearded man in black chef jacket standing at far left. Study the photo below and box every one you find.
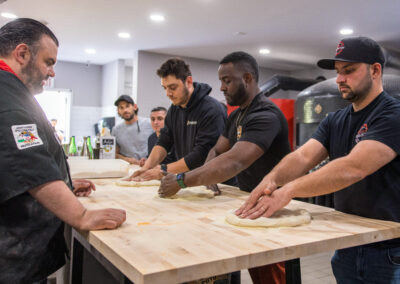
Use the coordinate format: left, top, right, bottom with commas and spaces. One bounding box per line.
0, 18, 125, 283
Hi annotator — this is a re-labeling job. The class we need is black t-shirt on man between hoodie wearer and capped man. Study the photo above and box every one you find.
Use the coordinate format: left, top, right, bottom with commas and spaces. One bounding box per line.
222, 94, 290, 192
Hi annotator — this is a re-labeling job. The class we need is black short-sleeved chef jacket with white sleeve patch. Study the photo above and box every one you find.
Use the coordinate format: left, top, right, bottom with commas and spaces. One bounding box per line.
0, 70, 72, 283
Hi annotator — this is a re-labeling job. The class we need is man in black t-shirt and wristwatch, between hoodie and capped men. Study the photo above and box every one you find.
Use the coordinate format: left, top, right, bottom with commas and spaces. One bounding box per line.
159, 52, 290, 283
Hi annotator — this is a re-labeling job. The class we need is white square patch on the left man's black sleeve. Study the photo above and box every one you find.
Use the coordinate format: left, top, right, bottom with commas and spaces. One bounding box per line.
11, 124, 43, 150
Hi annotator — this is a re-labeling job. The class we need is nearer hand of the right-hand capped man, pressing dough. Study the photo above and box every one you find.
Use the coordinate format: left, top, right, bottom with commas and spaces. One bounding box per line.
239, 187, 292, 219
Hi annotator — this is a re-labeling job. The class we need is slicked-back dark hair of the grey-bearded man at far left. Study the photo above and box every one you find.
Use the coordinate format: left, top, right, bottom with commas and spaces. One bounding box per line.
0, 18, 58, 57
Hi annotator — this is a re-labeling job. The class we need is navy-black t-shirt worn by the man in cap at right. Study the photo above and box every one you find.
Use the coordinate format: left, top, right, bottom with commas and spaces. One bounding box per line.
313, 92, 400, 223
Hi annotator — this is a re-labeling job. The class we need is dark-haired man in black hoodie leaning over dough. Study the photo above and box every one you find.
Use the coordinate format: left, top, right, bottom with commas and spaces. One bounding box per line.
131, 58, 226, 180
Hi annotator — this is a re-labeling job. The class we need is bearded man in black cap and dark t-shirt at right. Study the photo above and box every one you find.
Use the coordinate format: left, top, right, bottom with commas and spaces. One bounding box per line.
236, 37, 400, 283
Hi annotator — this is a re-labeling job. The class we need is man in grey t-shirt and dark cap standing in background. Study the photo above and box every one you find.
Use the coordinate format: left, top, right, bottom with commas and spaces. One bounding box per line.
111, 95, 153, 165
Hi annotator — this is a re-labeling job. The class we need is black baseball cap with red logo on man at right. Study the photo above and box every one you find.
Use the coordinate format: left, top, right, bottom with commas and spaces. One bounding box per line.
317, 37, 385, 69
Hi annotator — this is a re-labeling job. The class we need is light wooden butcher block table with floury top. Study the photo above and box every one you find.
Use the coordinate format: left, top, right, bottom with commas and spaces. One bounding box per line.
71, 179, 400, 284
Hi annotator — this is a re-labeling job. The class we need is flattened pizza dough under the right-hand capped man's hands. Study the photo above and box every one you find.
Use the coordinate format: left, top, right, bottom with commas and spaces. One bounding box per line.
225, 208, 311, 228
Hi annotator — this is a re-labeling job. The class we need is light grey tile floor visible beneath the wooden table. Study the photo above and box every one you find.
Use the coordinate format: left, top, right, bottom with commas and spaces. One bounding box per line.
241, 252, 336, 284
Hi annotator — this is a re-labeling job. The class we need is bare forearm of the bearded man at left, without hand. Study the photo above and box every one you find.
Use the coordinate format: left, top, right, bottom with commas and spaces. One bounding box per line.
29, 181, 86, 229
